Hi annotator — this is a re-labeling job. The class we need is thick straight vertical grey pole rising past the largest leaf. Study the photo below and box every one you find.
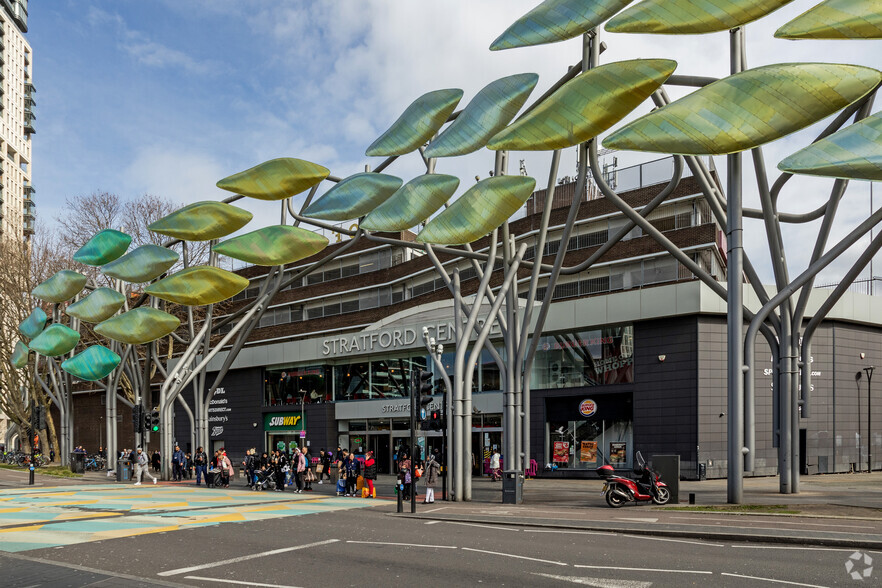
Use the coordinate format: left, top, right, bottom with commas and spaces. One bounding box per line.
726, 28, 744, 504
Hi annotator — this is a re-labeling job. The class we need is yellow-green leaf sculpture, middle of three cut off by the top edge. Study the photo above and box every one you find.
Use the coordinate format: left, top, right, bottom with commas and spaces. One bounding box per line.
605, 0, 793, 35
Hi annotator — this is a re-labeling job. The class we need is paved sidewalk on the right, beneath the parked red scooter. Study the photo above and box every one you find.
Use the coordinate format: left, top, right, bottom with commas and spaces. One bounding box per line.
386, 473, 882, 550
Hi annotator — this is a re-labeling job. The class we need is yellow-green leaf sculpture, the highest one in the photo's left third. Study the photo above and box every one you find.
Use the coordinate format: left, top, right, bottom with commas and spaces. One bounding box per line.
217, 157, 331, 200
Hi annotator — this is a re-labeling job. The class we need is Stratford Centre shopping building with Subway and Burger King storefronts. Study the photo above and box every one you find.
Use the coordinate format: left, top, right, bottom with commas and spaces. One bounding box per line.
70, 158, 882, 478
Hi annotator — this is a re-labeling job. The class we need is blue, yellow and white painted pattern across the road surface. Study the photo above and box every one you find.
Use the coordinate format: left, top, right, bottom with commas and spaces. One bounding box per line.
0, 485, 377, 552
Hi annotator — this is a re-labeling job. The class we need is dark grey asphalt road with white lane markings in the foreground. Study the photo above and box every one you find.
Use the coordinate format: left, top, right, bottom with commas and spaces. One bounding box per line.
0, 506, 882, 588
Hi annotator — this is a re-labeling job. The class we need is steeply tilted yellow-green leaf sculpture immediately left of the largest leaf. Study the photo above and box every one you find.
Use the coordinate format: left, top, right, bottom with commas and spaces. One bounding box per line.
487, 59, 677, 151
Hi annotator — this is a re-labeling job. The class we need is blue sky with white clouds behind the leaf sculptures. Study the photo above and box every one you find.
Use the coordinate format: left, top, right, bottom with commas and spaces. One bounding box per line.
27, 0, 882, 282
